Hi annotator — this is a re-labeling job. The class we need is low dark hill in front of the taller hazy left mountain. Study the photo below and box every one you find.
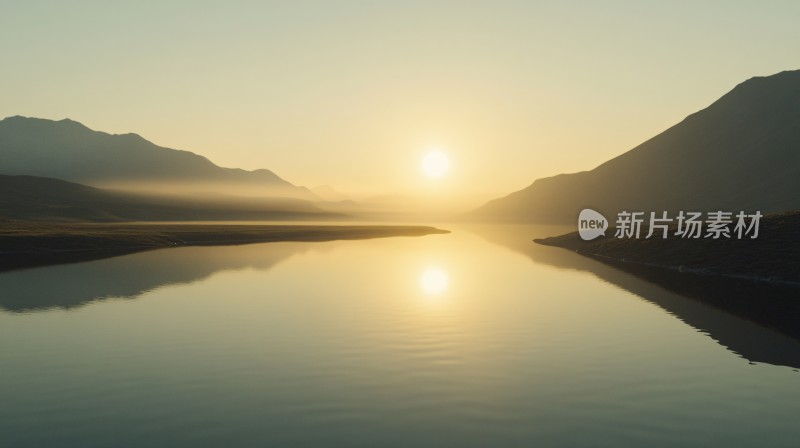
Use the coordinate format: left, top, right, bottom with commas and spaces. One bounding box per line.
0, 175, 334, 222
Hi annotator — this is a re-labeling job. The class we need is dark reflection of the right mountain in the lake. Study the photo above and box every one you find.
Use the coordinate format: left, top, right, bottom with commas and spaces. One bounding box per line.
470, 225, 800, 368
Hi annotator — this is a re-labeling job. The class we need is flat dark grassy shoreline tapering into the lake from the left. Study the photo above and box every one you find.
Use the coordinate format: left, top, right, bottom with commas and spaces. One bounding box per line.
0, 221, 449, 271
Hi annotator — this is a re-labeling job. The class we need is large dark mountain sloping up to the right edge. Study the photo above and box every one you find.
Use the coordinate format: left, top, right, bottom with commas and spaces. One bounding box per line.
469, 70, 800, 223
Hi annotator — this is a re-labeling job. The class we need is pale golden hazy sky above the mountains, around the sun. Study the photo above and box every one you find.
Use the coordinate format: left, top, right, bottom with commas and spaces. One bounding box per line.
0, 0, 800, 203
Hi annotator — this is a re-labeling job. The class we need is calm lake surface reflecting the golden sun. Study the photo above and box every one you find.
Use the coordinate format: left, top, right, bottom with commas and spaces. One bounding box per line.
0, 225, 800, 448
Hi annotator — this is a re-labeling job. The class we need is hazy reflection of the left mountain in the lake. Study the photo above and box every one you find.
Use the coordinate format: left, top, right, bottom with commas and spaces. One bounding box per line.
0, 243, 310, 312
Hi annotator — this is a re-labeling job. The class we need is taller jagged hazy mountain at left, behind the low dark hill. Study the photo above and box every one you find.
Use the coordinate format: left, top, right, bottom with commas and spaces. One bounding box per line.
0, 116, 317, 200
